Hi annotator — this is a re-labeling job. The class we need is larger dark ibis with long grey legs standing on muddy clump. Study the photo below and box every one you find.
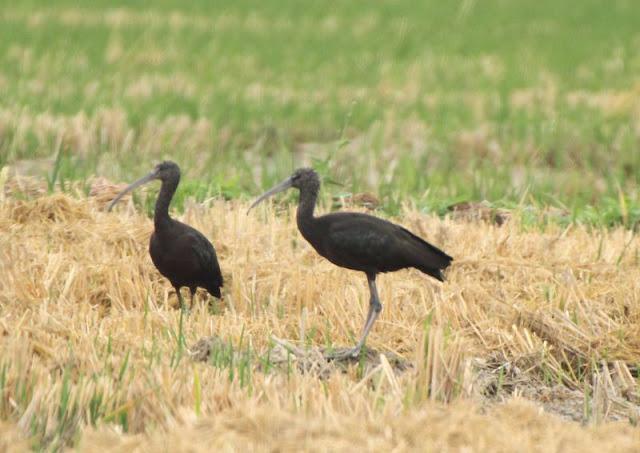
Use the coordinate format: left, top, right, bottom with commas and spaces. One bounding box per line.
249, 168, 453, 358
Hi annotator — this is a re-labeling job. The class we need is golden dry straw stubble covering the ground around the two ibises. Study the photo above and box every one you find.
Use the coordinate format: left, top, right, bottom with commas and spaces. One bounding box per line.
0, 184, 640, 452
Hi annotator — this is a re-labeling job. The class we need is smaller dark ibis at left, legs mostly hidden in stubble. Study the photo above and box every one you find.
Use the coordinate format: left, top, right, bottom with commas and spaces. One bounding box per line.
107, 161, 222, 309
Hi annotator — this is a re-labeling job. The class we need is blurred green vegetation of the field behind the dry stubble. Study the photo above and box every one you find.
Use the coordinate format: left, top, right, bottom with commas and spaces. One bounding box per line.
0, 0, 640, 227
